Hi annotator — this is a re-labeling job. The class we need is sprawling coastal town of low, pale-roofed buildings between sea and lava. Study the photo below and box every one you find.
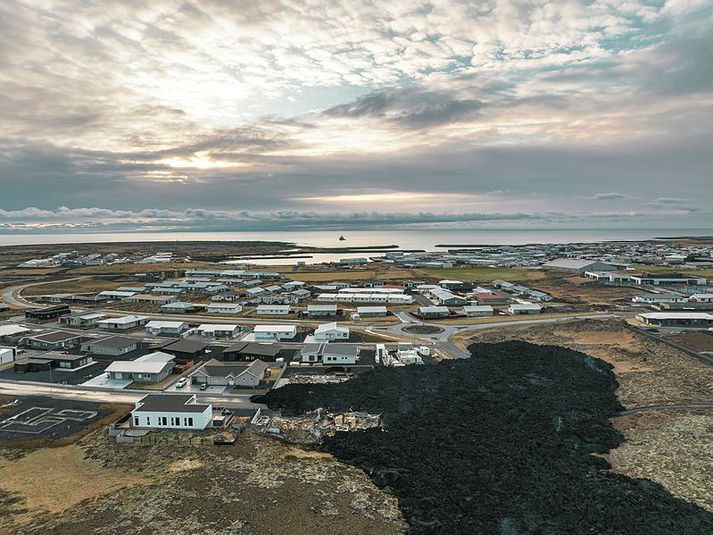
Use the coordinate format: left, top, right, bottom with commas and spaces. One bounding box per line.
0, 240, 713, 532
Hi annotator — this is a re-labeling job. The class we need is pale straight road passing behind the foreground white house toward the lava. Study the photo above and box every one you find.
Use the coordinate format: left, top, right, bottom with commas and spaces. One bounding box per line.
0, 381, 260, 409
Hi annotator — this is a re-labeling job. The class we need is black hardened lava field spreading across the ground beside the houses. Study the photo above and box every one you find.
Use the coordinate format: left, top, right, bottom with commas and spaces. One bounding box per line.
260, 342, 713, 535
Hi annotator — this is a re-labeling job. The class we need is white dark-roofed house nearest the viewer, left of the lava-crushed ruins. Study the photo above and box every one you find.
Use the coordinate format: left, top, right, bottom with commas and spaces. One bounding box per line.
131, 394, 213, 430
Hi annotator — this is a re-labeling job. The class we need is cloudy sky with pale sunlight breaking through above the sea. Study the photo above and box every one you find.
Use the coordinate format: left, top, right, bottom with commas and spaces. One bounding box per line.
0, 0, 713, 233
